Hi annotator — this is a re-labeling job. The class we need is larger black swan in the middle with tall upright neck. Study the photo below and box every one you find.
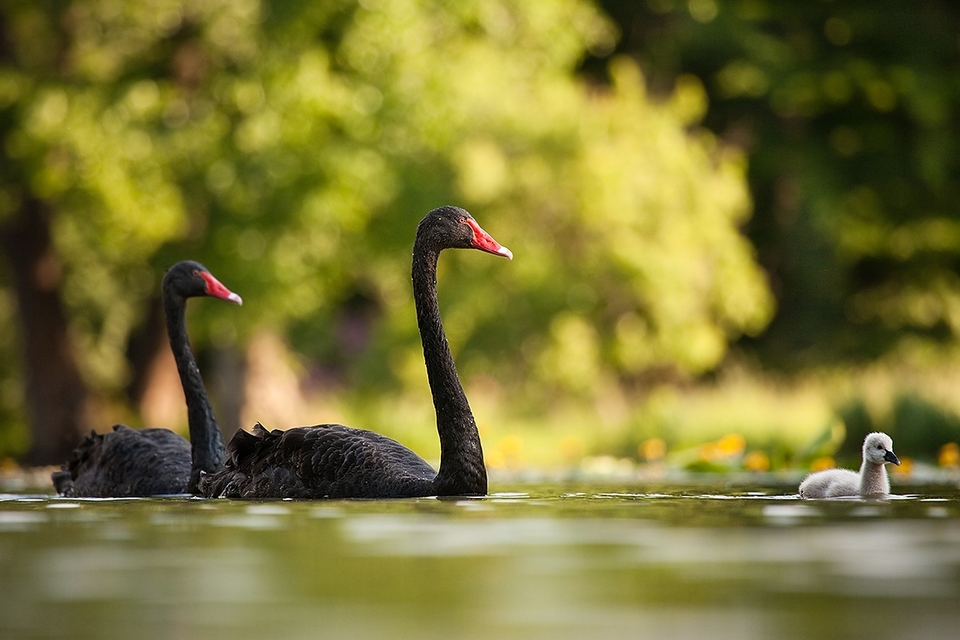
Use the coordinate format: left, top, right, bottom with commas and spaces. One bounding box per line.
200, 206, 513, 498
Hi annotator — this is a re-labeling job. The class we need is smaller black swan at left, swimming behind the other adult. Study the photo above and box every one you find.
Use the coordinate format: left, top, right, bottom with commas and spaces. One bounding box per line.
52, 260, 243, 498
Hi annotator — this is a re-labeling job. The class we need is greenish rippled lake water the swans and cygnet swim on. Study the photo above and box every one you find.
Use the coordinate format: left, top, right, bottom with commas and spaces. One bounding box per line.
0, 484, 960, 640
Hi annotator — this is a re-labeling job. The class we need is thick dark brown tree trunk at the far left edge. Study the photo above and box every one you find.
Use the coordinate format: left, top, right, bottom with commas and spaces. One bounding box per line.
0, 196, 87, 465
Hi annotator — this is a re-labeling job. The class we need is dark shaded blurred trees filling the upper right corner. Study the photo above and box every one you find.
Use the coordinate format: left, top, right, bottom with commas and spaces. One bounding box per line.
586, 0, 960, 365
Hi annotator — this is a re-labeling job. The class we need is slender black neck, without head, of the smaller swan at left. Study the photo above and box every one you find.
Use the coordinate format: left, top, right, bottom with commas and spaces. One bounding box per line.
163, 292, 224, 493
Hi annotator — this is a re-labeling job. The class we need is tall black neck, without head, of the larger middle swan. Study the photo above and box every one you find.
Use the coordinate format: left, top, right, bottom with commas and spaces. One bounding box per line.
413, 237, 487, 495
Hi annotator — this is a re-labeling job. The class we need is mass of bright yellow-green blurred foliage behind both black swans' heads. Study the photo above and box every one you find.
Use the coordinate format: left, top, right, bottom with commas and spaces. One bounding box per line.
0, 0, 772, 460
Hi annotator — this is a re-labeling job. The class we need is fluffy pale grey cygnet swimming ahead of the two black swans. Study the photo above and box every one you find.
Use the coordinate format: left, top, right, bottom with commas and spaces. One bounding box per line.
800, 432, 900, 498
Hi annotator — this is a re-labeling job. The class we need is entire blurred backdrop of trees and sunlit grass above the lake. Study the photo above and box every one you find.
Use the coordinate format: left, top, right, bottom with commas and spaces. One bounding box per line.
0, 0, 960, 480
